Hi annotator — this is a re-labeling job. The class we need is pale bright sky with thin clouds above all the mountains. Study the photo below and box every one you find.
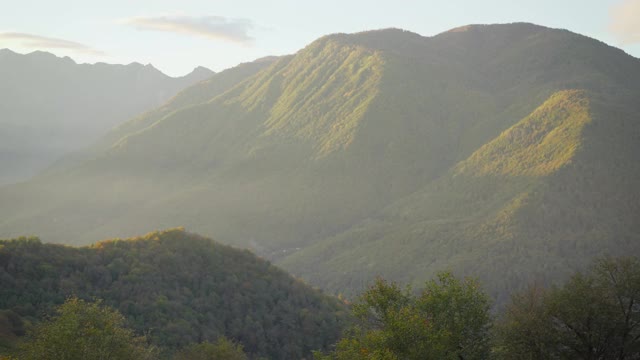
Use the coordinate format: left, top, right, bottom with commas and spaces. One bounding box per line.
0, 0, 640, 76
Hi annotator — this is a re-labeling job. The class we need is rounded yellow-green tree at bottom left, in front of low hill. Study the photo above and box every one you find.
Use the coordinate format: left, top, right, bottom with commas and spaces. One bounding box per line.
19, 297, 152, 360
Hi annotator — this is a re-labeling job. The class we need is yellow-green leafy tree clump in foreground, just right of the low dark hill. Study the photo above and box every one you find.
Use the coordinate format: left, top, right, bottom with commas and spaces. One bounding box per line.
315, 273, 491, 360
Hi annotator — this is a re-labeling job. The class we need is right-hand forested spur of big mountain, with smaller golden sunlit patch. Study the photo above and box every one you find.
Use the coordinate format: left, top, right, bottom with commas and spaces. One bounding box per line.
282, 90, 640, 301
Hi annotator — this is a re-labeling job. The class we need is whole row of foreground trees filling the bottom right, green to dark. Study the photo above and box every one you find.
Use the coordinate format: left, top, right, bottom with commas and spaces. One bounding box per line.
316, 258, 640, 360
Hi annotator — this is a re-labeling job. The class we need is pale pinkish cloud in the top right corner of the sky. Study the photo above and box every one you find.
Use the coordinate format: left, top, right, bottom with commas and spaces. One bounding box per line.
609, 0, 640, 44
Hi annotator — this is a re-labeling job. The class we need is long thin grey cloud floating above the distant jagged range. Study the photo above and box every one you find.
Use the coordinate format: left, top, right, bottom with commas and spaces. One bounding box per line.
122, 15, 255, 44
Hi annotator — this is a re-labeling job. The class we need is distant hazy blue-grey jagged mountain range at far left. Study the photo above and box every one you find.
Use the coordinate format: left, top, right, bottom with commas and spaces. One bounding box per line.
0, 49, 214, 184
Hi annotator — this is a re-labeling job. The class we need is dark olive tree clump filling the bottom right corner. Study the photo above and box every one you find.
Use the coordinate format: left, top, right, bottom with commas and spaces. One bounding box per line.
496, 258, 640, 360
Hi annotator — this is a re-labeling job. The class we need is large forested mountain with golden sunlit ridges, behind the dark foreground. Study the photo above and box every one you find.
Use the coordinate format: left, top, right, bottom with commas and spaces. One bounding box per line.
0, 23, 640, 301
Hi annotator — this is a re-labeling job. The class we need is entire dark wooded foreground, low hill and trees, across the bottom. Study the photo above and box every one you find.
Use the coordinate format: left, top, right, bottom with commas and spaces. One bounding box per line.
0, 229, 640, 360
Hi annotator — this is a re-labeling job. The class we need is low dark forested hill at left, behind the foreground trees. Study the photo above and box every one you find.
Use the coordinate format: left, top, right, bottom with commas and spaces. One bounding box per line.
0, 229, 350, 359
